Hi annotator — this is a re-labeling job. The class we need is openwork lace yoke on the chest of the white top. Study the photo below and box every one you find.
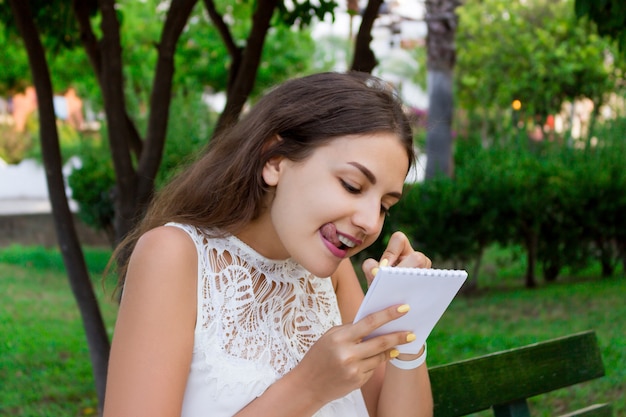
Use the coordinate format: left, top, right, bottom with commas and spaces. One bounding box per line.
198, 231, 339, 370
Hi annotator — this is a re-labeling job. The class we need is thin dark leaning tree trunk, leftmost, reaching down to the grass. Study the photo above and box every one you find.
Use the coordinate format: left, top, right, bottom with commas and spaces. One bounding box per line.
10, 0, 110, 408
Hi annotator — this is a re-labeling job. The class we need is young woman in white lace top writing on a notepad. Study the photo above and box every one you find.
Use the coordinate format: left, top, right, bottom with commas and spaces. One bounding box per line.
104, 73, 432, 417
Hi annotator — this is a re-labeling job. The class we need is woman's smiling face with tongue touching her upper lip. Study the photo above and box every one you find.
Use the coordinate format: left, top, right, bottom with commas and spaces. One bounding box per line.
240, 133, 409, 277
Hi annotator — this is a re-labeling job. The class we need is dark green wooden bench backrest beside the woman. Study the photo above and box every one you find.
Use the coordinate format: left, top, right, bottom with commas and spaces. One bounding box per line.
429, 331, 612, 417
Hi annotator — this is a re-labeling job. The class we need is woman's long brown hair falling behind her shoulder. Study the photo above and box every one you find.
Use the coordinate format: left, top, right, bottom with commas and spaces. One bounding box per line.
116, 72, 415, 284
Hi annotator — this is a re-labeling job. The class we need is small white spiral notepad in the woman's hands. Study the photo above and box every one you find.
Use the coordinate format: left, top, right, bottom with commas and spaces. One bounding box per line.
354, 266, 467, 353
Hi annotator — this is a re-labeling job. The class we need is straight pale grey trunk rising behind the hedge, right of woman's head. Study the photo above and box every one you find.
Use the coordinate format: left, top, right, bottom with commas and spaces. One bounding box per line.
425, 0, 460, 179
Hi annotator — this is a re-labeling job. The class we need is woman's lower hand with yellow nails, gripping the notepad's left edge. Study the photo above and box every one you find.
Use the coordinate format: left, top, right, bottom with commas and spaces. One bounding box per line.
292, 305, 410, 407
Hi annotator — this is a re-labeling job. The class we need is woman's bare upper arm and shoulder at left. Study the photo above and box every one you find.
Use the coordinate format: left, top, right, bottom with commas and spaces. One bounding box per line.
104, 227, 198, 417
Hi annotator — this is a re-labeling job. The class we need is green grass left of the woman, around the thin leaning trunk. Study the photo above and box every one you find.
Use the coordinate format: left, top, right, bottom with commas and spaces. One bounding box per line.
0, 246, 116, 417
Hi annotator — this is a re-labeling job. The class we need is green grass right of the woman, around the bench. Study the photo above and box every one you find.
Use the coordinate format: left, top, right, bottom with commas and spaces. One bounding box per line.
428, 248, 626, 417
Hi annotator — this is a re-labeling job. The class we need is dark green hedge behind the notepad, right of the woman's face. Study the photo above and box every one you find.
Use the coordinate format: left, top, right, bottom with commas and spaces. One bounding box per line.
376, 118, 626, 288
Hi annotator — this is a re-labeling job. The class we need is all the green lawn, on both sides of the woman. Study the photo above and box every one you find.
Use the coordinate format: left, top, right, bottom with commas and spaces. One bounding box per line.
0, 242, 626, 417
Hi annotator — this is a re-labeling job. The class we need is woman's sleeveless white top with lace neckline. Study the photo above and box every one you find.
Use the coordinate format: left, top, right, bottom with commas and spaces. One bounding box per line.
168, 223, 368, 417
